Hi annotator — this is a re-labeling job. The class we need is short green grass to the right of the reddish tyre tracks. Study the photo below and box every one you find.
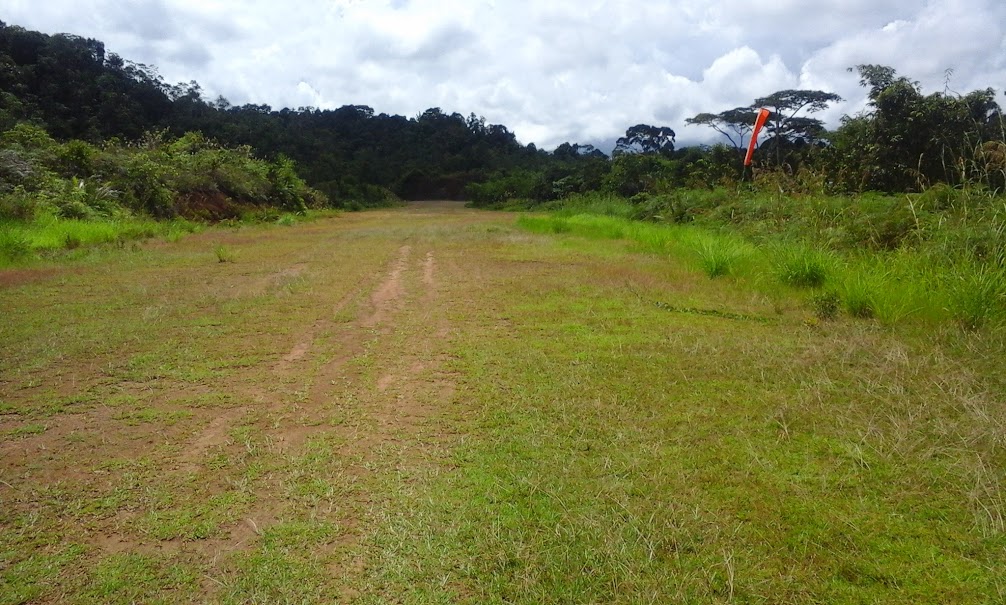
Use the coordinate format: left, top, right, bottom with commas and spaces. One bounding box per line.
352, 230, 1006, 603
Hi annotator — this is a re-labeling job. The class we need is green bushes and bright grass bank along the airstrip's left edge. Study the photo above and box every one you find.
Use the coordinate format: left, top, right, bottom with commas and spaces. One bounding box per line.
0, 124, 338, 265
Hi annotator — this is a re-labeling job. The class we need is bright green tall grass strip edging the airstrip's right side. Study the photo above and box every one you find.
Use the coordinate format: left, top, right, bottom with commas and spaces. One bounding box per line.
518, 196, 1006, 330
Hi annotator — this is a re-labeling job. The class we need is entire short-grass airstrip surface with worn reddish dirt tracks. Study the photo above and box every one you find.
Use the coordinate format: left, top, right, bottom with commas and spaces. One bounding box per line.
0, 208, 1006, 604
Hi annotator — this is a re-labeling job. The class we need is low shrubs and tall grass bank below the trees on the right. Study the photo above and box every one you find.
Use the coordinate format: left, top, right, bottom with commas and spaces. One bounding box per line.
519, 186, 1006, 330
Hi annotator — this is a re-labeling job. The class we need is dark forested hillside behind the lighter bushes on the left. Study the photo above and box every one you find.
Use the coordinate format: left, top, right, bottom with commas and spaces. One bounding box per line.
0, 20, 545, 205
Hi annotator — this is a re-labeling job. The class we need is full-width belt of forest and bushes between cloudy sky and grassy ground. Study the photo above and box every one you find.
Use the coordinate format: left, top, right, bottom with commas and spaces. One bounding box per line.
0, 22, 1006, 222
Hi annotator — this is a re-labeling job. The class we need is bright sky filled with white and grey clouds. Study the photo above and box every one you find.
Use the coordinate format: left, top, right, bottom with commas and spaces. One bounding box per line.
0, 0, 1006, 151
